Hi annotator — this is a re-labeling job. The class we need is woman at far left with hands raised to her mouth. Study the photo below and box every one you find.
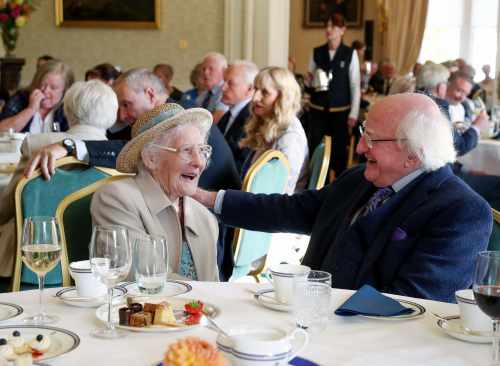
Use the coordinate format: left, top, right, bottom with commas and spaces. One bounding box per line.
0, 60, 74, 133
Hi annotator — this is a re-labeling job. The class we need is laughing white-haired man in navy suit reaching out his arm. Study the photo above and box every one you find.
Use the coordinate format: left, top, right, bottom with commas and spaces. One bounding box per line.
196, 93, 492, 302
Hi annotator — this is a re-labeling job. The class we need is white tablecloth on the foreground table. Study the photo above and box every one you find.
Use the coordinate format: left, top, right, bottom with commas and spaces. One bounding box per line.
0, 282, 490, 366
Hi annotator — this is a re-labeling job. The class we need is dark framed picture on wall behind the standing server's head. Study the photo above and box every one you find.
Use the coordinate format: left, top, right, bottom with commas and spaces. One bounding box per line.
303, 0, 363, 28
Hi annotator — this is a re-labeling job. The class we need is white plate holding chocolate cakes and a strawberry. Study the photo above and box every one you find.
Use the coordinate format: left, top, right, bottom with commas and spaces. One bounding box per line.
96, 297, 219, 333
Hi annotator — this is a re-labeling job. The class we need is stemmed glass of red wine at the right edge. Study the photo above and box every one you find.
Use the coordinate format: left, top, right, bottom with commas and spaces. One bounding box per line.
473, 251, 500, 366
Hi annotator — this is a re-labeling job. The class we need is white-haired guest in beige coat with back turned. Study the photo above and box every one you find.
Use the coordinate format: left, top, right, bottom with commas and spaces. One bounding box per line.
0, 80, 118, 277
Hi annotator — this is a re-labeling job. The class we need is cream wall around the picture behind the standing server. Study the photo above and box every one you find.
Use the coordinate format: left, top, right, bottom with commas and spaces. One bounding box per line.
290, 0, 379, 73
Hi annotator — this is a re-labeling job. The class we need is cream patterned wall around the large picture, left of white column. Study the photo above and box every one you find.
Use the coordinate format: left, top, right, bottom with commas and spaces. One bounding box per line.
9, 0, 224, 89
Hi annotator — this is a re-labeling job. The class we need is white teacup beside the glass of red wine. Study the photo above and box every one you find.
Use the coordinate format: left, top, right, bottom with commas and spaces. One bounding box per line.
455, 289, 492, 332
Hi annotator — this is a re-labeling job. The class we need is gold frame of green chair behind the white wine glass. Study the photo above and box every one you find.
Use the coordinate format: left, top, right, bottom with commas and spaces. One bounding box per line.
11, 157, 123, 291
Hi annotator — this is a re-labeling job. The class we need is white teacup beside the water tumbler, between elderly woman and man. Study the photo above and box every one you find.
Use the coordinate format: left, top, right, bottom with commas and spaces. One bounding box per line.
269, 264, 311, 304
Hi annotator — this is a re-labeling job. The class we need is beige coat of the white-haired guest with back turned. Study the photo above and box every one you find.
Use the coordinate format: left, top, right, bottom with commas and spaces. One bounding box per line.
0, 125, 106, 277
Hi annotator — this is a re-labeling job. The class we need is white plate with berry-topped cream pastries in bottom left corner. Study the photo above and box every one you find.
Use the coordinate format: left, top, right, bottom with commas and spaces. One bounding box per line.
0, 325, 80, 361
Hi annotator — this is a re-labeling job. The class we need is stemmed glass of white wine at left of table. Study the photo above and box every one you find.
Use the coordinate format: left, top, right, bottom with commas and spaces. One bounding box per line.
21, 216, 61, 324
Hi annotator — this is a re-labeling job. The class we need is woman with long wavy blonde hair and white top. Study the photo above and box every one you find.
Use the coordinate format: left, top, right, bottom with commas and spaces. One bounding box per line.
240, 67, 309, 193
